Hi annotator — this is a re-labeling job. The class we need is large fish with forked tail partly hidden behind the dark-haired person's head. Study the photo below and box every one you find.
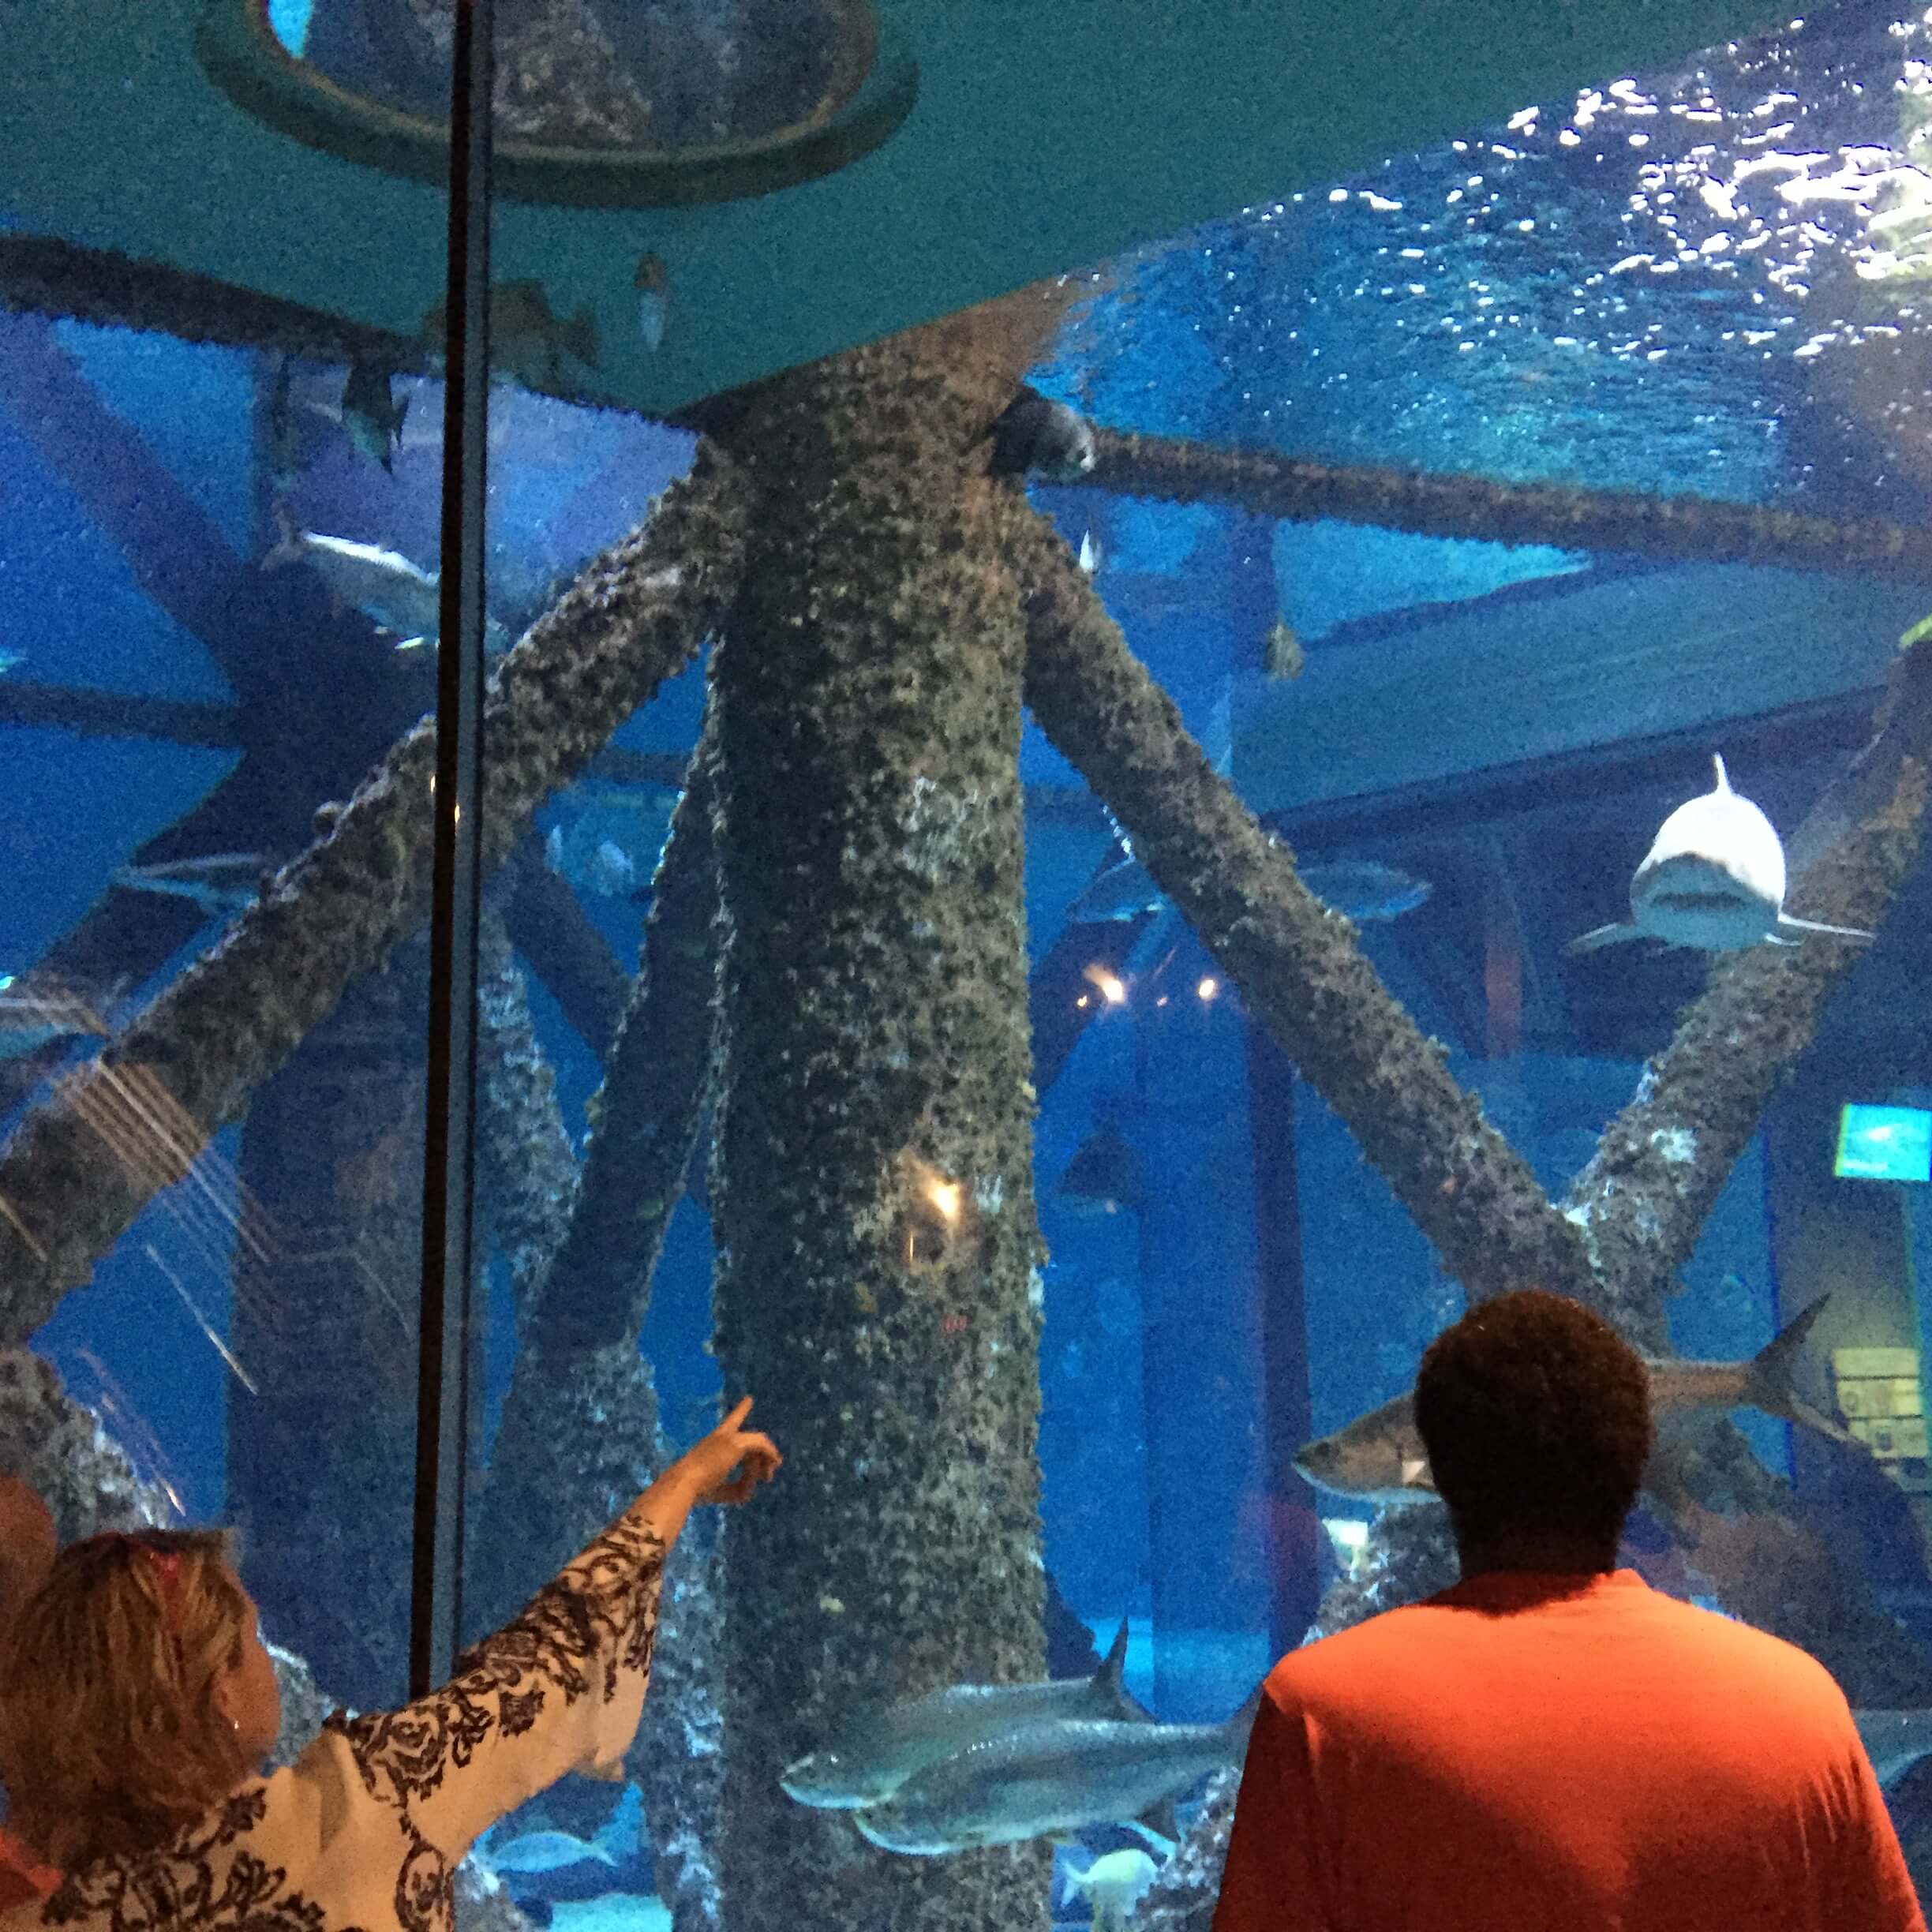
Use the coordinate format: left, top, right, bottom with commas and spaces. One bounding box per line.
1294, 1294, 1853, 1501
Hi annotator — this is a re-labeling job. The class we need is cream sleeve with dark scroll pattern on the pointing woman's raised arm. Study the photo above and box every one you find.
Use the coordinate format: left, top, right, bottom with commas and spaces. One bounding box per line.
331, 1517, 665, 1864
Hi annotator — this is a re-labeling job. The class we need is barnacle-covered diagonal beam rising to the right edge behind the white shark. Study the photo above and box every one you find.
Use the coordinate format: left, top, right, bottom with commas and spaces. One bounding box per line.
1563, 642, 1932, 1337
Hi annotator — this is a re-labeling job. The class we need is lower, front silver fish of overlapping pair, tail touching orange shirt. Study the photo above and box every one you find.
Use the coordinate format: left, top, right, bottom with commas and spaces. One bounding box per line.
852, 1690, 1262, 1859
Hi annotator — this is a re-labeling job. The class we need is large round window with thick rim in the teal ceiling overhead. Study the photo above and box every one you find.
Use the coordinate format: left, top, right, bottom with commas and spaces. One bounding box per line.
197, 0, 918, 207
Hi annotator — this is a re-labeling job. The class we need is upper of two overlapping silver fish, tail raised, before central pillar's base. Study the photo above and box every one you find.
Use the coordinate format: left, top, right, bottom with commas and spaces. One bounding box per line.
779, 1617, 1148, 1810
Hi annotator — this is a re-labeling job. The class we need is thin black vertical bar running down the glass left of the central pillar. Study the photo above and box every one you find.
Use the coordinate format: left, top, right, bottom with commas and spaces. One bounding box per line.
410, 0, 495, 1696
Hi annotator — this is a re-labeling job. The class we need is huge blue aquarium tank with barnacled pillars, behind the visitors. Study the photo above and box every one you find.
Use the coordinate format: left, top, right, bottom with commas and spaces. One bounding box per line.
0, 0, 1932, 1932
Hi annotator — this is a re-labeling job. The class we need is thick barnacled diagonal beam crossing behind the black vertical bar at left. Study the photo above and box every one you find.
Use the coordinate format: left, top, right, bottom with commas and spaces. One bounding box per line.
0, 450, 743, 1339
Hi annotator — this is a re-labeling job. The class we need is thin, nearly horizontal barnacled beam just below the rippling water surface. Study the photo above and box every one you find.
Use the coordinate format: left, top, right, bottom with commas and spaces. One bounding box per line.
1078, 429, 1932, 583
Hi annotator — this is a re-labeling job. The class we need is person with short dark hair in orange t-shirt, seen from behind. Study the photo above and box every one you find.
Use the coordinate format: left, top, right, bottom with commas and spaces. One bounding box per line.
1215, 1290, 1924, 1932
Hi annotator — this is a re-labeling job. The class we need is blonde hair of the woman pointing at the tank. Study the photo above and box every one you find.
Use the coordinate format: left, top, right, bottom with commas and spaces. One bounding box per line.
0, 1530, 253, 1870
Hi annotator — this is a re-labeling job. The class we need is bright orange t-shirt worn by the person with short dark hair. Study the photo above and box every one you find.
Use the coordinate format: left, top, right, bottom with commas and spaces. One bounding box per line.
1213, 1571, 1924, 1932
